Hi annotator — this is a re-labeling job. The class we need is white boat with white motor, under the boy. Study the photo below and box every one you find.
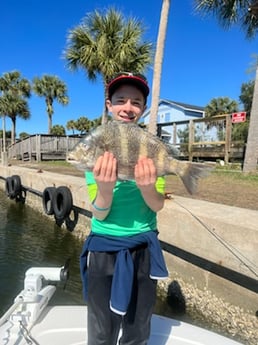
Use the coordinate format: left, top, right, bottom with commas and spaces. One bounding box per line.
0, 266, 243, 345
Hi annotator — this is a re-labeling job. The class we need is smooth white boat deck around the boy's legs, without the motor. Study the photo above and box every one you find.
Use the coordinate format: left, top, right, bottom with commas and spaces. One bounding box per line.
0, 306, 243, 345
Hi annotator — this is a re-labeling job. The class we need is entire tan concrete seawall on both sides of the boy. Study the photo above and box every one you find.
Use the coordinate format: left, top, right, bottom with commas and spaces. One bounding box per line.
0, 165, 258, 338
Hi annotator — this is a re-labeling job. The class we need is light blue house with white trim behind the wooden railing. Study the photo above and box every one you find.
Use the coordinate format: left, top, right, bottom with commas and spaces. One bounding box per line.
142, 99, 205, 143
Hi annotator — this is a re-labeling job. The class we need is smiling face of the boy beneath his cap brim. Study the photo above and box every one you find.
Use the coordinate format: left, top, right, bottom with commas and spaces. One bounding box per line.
106, 84, 146, 122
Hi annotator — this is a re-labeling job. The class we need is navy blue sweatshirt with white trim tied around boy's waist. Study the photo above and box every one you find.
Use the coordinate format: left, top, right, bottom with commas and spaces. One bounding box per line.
80, 231, 168, 315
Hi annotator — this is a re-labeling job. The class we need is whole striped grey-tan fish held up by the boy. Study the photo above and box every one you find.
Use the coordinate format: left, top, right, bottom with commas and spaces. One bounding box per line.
67, 121, 214, 194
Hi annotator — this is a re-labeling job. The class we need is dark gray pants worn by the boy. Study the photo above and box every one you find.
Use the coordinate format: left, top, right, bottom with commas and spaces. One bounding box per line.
88, 248, 157, 345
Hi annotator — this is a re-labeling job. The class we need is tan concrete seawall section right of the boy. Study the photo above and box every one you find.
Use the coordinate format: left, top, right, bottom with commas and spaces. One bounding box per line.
159, 196, 258, 313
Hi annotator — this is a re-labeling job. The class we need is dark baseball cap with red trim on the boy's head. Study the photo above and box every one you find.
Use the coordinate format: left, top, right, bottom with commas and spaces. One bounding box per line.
107, 72, 150, 101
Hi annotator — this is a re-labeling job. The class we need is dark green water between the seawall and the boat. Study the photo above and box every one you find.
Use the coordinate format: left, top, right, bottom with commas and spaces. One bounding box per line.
0, 191, 84, 315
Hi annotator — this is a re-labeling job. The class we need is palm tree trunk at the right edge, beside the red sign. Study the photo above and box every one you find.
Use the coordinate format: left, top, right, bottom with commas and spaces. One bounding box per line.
243, 66, 258, 173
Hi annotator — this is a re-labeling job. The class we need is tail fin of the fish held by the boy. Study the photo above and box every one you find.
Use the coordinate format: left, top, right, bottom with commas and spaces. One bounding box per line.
173, 161, 214, 194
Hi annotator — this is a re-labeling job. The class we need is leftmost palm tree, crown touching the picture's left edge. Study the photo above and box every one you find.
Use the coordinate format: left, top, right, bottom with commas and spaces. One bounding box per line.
0, 71, 31, 145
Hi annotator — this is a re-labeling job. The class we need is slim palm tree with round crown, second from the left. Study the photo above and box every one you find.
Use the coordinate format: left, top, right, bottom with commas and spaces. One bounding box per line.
32, 75, 69, 134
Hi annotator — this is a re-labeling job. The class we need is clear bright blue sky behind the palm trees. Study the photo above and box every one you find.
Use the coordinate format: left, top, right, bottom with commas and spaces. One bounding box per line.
0, 0, 258, 136
